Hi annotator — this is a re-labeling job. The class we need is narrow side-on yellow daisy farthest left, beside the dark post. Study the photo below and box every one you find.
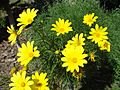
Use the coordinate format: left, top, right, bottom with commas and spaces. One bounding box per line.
7, 25, 18, 45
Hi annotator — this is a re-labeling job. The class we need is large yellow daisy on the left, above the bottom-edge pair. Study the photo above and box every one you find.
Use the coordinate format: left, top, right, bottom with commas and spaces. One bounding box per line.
17, 41, 40, 66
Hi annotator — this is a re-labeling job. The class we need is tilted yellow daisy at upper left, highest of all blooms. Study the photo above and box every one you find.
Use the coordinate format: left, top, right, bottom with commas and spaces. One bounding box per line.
17, 8, 38, 26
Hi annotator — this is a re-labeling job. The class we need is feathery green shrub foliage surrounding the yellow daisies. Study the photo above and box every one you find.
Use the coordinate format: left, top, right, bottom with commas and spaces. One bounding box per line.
24, 0, 120, 90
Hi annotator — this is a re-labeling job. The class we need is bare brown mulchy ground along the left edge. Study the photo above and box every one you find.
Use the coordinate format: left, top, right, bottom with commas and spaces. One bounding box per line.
0, 41, 17, 90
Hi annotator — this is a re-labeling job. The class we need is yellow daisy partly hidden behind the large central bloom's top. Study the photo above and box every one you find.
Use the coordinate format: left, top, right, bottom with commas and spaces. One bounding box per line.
66, 33, 85, 47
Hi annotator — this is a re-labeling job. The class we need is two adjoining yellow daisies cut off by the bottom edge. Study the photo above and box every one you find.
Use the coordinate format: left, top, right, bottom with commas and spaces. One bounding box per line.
9, 71, 49, 90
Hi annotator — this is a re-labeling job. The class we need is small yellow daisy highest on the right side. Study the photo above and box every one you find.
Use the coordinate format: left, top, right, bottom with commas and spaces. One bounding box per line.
83, 13, 98, 27
